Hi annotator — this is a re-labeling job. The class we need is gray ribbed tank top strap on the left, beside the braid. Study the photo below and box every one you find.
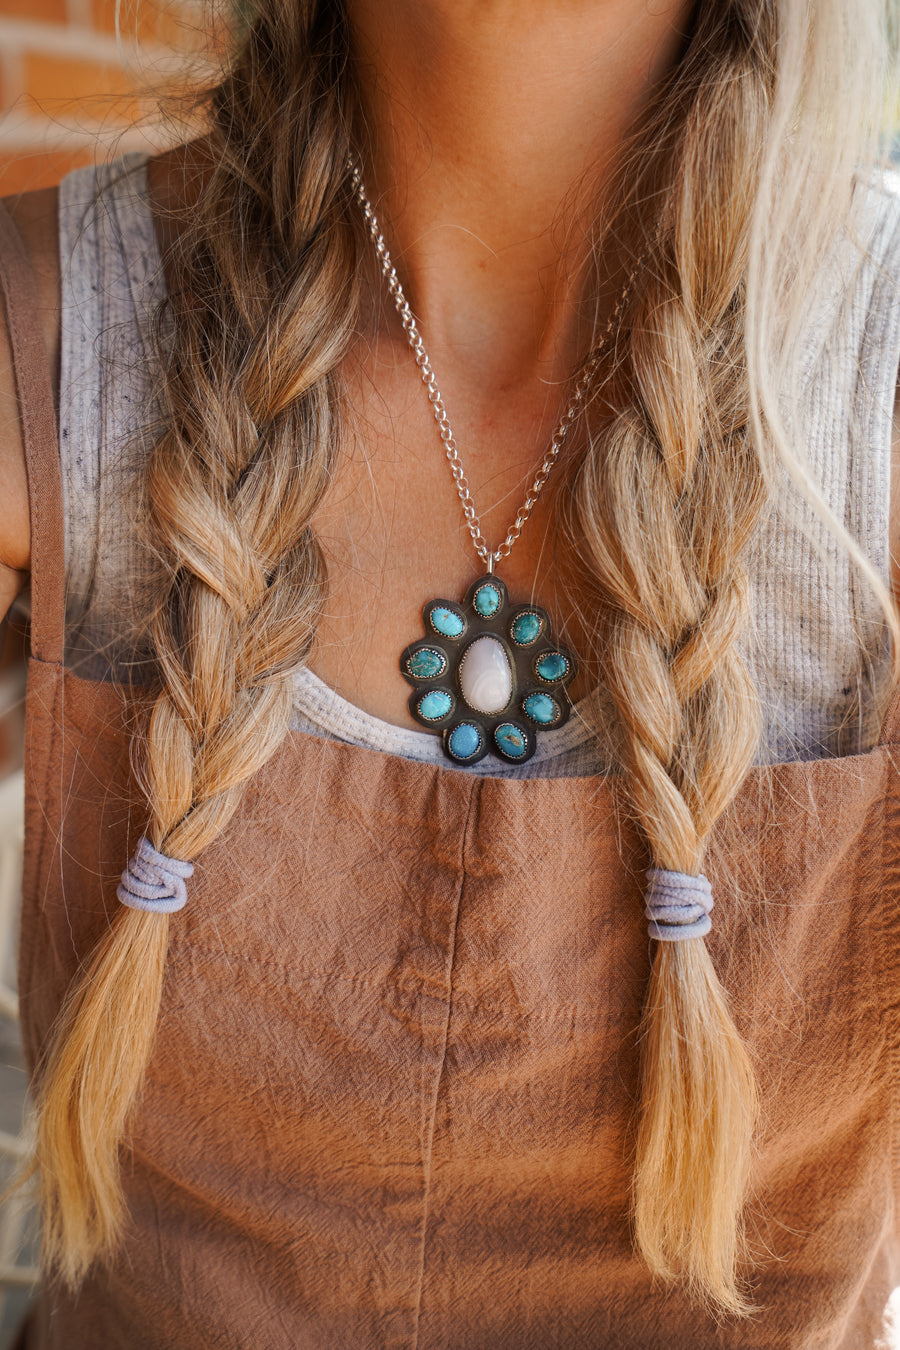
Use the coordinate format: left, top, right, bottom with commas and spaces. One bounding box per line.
59, 155, 165, 680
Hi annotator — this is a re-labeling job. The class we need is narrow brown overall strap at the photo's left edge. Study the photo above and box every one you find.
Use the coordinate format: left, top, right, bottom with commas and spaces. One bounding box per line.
0, 203, 65, 662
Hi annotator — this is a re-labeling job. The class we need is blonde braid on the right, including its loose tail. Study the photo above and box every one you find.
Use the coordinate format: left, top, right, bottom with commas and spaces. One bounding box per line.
572, 7, 768, 1314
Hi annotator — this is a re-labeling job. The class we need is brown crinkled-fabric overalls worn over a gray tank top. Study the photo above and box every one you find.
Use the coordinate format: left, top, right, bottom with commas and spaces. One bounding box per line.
0, 202, 900, 1350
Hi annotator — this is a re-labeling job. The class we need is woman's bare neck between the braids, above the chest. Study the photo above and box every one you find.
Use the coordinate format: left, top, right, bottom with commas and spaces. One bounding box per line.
347, 0, 692, 393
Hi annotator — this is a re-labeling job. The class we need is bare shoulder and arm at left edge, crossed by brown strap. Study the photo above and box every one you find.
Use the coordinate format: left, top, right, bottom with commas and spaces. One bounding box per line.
0, 189, 59, 617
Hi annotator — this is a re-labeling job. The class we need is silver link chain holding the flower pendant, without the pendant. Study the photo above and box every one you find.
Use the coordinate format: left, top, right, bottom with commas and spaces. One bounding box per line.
349, 159, 642, 572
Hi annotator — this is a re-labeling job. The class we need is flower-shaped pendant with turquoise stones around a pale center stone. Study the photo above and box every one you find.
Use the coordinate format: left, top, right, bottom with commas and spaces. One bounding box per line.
399, 574, 578, 764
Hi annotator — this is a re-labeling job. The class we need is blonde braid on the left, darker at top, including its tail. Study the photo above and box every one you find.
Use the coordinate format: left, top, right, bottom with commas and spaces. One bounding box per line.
36, 3, 358, 1284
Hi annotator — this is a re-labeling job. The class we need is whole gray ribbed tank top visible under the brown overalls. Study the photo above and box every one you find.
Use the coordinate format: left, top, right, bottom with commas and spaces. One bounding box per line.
59, 155, 900, 776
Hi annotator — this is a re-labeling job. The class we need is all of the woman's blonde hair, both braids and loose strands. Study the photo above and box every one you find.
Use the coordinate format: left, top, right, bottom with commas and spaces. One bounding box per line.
26, 0, 892, 1315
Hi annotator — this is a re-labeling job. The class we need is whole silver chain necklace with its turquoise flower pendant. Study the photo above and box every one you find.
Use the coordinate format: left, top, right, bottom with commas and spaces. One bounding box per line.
349, 159, 640, 764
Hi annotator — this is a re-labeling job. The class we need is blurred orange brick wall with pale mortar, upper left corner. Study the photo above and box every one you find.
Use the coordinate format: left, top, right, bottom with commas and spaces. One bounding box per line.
0, 0, 209, 196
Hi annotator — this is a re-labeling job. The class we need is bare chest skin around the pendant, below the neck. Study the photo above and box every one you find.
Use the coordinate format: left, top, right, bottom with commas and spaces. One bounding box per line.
309, 352, 591, 728
